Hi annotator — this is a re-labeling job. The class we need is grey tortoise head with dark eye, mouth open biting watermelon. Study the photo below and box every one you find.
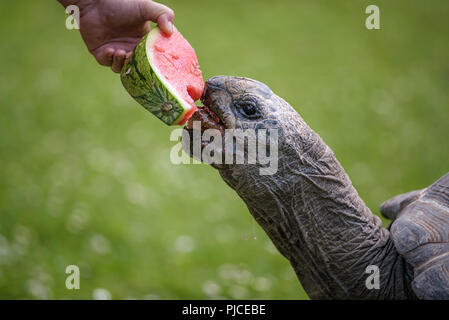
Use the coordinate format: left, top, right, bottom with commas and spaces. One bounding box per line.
186, 76, 290, 179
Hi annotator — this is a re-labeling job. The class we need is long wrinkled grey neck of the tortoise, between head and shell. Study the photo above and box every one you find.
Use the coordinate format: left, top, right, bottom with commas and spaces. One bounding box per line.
221, 123, 394, 299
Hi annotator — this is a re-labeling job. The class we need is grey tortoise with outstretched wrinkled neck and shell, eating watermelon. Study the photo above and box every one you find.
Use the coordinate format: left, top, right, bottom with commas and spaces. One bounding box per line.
187, 76, 449, 299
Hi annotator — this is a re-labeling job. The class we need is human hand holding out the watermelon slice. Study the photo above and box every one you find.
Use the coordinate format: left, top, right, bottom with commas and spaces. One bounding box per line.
59, 0, 175, 72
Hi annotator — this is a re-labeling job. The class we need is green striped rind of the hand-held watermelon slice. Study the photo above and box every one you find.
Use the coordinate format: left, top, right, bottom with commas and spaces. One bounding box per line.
120, 27, 195, 125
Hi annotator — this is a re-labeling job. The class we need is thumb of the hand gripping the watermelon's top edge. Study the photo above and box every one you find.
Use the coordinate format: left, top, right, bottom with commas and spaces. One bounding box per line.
139, 0, 175, 35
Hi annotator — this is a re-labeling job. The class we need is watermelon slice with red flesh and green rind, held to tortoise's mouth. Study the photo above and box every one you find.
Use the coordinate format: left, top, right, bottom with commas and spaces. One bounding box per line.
121, 28, 204, 125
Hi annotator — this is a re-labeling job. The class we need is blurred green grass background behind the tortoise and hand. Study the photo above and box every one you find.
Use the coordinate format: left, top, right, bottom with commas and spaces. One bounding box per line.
0, 0, 449, 299
